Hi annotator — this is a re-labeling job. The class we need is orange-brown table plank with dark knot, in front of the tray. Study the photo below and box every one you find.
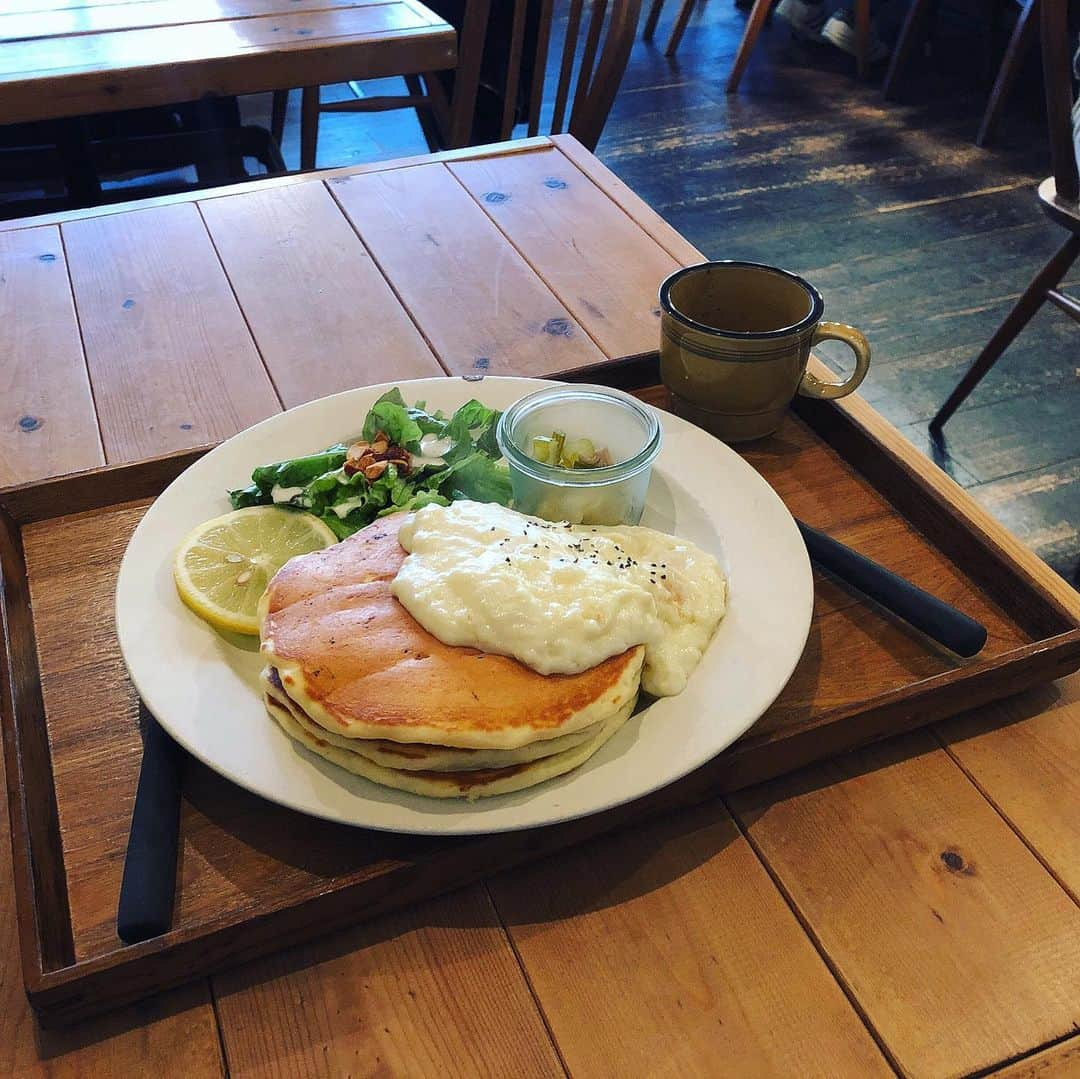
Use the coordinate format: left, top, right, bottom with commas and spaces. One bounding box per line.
731, 732, 1080, 1076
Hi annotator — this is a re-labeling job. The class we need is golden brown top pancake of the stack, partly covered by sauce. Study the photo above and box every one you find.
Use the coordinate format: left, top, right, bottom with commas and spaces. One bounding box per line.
261, 514, 645, 750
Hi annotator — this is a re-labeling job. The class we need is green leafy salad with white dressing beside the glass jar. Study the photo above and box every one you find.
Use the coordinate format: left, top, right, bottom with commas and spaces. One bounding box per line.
229, 387, 511, 539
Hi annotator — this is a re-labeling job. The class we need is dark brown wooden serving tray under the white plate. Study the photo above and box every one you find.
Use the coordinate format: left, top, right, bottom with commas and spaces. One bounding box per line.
0, 355, 1080, 1024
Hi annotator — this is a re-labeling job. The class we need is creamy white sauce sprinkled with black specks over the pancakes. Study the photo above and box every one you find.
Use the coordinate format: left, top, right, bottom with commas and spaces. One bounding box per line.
391, 501, 727, 697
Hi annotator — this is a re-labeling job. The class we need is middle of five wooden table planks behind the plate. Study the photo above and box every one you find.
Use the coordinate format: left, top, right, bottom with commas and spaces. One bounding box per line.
200, 184, 444, 407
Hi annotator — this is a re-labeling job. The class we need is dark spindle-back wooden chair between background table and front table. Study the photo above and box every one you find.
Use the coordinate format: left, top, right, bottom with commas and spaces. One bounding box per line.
289, 0, 642, 168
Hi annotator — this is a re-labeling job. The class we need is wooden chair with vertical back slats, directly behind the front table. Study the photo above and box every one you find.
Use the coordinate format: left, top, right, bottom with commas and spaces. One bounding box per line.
274, 0, 642, 168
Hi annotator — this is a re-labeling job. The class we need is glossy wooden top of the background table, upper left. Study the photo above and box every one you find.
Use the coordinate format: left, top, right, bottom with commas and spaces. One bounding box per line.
0, 0, 457, 123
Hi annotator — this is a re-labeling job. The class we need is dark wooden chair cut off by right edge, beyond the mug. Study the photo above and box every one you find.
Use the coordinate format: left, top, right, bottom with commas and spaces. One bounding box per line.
930, 0, 1080, 439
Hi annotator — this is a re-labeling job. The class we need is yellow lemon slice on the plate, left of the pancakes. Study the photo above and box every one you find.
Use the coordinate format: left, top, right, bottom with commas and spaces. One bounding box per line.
173, 505, 337, 634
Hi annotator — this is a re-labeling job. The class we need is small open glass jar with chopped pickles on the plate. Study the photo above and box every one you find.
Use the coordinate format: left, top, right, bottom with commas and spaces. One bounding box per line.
496, 386, 662, 525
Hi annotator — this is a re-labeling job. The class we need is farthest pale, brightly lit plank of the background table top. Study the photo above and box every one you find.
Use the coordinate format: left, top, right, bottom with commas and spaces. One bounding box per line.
0, 0, 382, 44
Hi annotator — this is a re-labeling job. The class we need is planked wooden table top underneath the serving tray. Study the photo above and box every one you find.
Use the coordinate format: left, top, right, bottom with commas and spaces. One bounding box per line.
0, 137, 1080, 1079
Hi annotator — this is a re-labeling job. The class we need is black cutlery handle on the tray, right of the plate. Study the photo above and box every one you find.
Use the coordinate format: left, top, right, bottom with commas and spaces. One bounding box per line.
796, 521, 986, 656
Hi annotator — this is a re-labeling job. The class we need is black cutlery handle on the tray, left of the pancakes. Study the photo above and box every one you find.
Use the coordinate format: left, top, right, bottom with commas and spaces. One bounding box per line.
117, 710, 184, 944
